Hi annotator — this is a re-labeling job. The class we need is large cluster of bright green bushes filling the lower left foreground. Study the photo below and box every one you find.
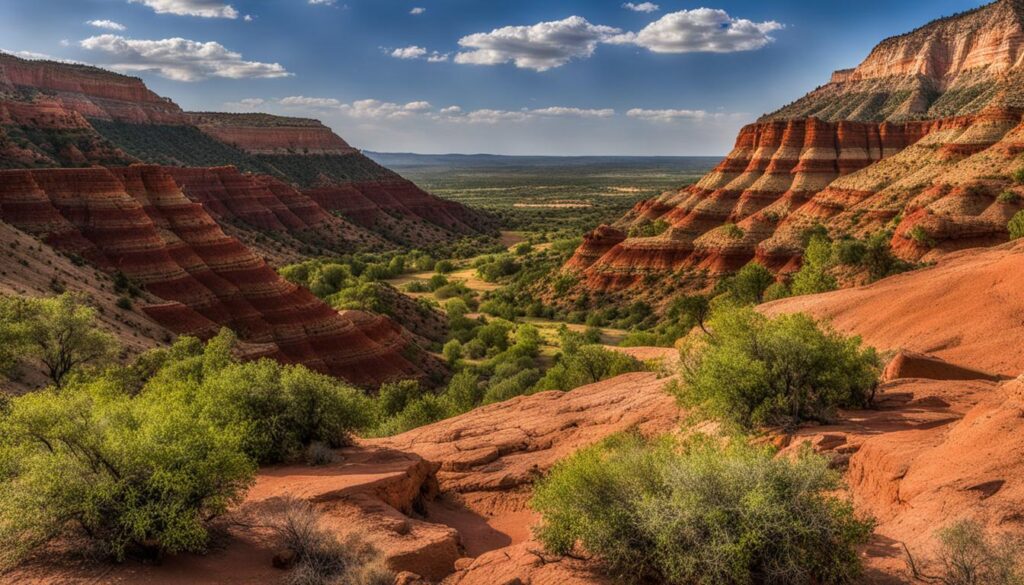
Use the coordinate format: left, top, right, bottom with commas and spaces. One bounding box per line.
0, 324, 374, 566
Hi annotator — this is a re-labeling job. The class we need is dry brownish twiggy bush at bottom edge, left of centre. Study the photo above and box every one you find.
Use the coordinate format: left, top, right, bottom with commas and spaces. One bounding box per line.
271, 500, 394, 585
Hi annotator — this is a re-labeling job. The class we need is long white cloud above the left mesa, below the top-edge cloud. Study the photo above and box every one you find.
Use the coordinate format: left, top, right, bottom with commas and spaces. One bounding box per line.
80, 35, 292, 81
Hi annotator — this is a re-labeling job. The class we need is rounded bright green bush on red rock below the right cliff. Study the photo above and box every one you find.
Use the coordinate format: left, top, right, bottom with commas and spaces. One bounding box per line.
681, 306, 881, 428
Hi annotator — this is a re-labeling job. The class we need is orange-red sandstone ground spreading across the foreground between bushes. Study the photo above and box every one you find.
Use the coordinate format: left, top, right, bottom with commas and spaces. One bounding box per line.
15, 244, 1024, 585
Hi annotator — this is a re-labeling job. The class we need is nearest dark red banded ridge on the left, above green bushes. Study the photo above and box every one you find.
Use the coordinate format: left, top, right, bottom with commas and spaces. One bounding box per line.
0, 166, 436, 385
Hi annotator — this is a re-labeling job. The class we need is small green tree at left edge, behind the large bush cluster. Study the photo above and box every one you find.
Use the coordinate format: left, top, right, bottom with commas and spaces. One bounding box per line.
0, 293, 118, 387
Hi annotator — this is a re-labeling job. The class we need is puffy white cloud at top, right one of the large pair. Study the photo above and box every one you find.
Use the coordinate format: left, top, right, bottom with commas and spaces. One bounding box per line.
609, 8, 783, 53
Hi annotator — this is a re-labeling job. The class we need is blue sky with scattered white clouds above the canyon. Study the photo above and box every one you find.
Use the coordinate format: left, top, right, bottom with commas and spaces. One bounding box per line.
0, 0, 982, 155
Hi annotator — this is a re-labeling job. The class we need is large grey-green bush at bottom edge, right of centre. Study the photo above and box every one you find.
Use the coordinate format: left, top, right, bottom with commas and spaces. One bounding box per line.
531, 435, 871, 585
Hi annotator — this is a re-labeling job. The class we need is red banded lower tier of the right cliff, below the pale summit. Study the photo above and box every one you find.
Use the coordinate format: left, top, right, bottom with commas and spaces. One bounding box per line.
567, 110, 1021, 290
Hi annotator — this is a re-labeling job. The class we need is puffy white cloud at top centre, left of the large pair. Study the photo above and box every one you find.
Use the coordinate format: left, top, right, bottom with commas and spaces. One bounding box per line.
455, 16, 622, 71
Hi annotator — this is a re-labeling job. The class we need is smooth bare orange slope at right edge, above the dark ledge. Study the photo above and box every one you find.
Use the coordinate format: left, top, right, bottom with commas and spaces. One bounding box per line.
762, 242, 1024, 376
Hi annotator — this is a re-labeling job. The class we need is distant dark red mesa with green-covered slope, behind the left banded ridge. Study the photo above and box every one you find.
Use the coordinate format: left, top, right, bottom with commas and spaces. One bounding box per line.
0, 53, 493, 251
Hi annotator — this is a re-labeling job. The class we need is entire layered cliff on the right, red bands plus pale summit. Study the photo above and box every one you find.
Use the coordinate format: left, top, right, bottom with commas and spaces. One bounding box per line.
566, 0, 1024, 300
